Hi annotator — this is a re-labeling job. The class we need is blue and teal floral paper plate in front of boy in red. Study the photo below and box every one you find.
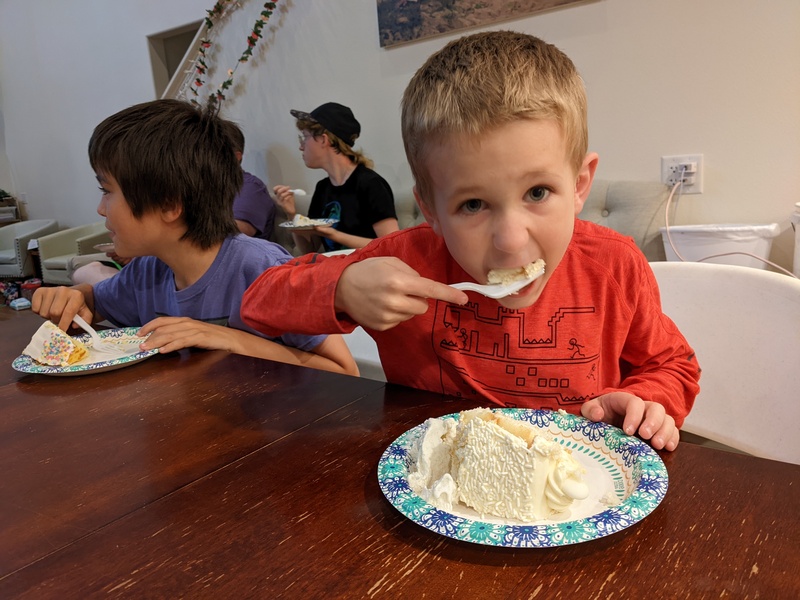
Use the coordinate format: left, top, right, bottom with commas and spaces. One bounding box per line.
378, 408, 668, 548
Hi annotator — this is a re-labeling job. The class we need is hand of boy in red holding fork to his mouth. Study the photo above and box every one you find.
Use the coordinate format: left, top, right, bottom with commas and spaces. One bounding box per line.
335, 257, 469, 331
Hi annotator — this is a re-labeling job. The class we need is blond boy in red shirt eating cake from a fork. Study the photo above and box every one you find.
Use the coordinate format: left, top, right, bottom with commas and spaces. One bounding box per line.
242, 31, 699, 450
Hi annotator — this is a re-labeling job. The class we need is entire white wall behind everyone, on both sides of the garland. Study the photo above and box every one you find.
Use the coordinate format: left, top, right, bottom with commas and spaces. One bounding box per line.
0, 0, 800, 267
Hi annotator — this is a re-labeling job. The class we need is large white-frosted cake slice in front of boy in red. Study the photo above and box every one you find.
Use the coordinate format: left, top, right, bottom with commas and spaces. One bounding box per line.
408, 408, 589, 523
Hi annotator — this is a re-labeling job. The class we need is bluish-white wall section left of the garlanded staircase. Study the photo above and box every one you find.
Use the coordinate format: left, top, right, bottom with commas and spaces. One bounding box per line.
0, 0, 210, 217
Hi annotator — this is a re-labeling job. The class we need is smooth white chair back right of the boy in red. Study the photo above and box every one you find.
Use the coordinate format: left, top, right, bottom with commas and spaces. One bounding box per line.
650, 262, 800, 464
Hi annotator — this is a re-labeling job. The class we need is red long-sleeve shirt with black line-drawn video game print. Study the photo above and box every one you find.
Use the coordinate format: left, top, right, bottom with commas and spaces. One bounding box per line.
242, 220, 700, 426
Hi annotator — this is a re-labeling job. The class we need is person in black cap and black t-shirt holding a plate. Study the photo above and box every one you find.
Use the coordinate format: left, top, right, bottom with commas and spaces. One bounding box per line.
273, 102, 399, 254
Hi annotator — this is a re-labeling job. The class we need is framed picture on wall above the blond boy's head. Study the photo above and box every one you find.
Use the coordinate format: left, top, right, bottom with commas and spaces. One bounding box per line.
377, 0, 586, 48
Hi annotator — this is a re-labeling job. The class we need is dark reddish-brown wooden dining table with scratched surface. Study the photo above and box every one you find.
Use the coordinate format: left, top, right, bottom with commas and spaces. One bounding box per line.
0, 308, 800, 599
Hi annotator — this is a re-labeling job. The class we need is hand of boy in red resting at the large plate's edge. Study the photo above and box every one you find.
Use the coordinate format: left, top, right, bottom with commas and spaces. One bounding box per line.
581, 392, 680, 450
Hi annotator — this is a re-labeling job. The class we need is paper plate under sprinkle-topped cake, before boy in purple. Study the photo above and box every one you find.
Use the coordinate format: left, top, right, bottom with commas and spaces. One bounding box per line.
11, 327, 158, 375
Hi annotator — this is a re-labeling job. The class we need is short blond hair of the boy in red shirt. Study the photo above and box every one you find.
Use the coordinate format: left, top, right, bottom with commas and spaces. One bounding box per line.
402, 31, 589, 201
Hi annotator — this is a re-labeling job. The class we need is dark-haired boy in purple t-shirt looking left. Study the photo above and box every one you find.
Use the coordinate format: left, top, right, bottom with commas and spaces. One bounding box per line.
32, 100, 358, 375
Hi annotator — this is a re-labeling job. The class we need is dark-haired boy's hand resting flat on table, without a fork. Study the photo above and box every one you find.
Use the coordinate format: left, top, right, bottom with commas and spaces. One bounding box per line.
137, 317, 238, 354
